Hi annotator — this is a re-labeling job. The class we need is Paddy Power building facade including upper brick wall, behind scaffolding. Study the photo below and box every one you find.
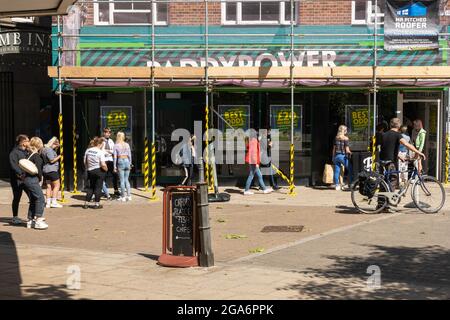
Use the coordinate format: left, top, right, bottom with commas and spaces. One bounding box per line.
49, 0, 450, 185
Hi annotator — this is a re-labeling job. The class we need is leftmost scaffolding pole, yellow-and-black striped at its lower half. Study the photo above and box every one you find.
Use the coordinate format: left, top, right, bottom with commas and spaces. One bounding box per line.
57, 15, 66, 203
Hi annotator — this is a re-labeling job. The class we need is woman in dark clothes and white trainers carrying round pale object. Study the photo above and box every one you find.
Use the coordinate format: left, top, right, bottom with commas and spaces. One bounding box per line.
24, 137, 48, 230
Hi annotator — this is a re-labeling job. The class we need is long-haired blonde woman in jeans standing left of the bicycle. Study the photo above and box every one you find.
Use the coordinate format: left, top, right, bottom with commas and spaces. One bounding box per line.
333, 125, 352, 190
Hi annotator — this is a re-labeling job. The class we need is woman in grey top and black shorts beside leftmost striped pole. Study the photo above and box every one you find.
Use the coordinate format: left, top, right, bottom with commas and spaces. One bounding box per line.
42, 137, 62, 208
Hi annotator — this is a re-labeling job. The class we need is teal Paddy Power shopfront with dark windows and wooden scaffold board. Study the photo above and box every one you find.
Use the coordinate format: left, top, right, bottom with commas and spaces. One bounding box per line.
51, 2, 450, 185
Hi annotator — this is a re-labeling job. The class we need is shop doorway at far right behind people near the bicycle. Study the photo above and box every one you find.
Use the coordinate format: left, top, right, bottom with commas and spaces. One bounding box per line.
403, 99, 442, 179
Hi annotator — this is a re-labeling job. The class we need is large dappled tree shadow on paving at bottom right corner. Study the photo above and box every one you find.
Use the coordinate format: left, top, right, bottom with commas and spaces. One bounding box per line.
279, 246, 450, 299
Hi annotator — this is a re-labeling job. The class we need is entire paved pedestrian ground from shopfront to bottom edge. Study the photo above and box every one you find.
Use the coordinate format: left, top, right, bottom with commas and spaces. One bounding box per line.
0, 182, 450, 300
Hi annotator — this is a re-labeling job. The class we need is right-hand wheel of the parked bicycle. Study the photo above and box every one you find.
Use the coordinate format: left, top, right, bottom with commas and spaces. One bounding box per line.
411, 176, 445, 213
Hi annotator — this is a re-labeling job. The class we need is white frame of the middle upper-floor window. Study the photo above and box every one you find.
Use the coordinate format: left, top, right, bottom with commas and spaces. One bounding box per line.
220, 0, 298, 26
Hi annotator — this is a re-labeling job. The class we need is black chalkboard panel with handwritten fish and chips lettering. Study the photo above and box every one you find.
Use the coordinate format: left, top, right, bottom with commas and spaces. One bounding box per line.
172, 192, 194, 256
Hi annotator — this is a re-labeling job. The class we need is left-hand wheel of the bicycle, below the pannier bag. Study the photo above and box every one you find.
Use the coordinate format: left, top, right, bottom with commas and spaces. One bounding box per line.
351, 179, 389, 213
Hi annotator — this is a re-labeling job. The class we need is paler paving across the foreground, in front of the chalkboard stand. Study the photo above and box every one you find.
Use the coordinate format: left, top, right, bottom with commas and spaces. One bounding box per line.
0, 214, 450, 300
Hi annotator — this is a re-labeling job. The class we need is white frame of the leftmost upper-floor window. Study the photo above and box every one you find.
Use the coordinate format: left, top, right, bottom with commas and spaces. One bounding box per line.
94, 0, 169, 26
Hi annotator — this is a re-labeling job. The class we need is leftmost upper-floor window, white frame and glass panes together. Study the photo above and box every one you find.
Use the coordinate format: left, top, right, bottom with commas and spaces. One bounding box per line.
94, 0, 168, 25
